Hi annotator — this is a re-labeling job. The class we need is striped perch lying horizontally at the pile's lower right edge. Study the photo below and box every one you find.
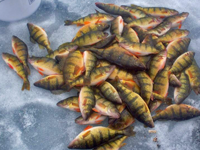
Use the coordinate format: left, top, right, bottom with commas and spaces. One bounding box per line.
153, 104, 200, 121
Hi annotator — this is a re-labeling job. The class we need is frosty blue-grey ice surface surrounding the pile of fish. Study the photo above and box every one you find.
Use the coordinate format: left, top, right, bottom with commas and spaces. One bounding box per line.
0, 0, 200, 150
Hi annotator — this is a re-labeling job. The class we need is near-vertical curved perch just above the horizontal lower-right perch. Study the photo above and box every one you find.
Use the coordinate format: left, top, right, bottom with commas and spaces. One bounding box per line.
174, 72, 191, 104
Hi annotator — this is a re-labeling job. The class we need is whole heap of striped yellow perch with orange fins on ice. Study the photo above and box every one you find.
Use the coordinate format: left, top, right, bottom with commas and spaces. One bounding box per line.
2, 2, 200, 150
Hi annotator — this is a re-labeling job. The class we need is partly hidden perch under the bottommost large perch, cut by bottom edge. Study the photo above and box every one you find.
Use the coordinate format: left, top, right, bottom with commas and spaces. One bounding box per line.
93, 136, 128, 150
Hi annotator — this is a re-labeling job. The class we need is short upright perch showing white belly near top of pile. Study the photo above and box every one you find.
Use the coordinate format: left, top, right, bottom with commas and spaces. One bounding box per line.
110, 16, 124, 35
